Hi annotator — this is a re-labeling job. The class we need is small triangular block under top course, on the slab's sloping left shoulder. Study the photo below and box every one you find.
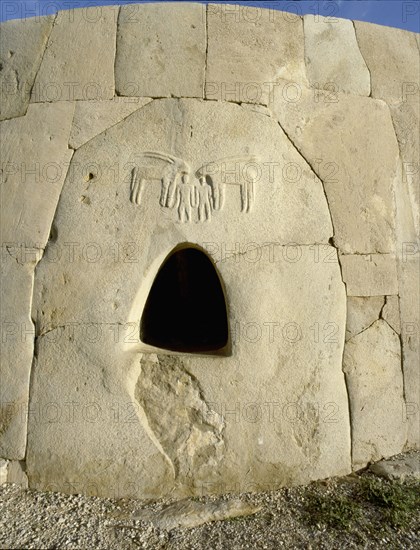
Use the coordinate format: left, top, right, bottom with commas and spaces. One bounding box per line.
69, 97, 152, 149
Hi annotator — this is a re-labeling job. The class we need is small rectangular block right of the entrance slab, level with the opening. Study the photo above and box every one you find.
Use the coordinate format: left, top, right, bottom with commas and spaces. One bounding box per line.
340, 254, 398, 296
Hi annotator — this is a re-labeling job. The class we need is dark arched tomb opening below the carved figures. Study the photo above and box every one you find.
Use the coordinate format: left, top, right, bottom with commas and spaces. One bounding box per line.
140, 247, 229, 355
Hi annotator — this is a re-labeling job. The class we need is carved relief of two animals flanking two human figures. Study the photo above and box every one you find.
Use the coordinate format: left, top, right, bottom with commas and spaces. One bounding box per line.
130, 151, 258, 223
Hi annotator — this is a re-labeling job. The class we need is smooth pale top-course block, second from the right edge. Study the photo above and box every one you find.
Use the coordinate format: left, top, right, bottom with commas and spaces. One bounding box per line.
303, 15, 370, 96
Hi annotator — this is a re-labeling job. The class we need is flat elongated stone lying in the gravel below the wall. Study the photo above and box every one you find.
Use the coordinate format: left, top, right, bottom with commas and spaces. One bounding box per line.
126, 499, 261, 531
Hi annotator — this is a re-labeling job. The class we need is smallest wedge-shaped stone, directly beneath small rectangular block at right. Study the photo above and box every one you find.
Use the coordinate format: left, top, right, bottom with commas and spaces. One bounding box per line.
346, 296, 384, 340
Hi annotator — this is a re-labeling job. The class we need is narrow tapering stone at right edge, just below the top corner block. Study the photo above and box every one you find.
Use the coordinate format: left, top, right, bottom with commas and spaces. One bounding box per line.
390, 102, 420, 235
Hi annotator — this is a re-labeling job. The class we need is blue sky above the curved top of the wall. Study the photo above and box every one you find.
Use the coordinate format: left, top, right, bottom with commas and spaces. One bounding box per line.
0, 0, 420, 32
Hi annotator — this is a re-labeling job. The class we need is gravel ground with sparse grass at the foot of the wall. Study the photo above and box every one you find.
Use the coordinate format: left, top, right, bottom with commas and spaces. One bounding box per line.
0, 452, 420, 550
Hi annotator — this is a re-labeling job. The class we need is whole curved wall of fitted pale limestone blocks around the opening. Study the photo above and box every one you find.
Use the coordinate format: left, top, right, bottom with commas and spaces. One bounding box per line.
0, 3, 420, 498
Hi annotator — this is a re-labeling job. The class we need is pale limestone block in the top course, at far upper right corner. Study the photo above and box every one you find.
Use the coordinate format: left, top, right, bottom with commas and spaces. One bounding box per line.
354, 21, 420, 104
